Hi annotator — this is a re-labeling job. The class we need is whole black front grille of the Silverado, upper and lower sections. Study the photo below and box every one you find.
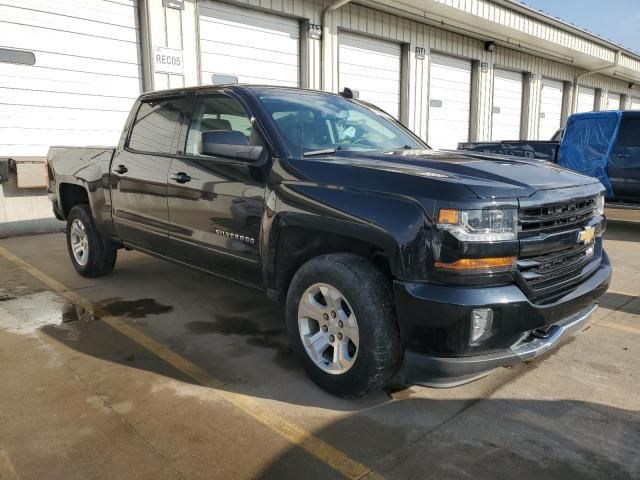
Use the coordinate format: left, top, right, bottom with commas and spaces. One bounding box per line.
517, 197, 601, 301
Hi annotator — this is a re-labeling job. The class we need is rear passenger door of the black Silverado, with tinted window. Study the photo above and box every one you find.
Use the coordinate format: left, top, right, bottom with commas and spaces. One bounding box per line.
110, 97, 186, 254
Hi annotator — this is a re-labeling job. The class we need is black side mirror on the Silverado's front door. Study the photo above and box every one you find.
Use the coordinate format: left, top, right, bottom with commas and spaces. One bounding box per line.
200, 130, 265, 164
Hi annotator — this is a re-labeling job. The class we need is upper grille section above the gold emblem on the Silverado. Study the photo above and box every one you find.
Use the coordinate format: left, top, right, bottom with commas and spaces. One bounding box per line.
518, 197, 596, 238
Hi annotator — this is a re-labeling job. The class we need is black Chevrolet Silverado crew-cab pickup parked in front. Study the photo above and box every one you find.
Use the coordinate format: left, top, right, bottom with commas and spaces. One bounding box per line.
48, 85, 611, 397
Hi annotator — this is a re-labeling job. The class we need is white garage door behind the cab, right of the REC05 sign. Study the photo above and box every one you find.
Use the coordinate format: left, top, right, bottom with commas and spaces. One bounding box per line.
200, 2, 300, 87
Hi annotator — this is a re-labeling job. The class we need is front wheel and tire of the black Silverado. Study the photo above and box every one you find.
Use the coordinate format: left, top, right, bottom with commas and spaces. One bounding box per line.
286, 253, 403, 398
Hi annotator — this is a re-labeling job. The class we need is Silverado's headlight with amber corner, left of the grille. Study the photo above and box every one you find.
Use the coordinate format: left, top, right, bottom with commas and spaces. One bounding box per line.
438, 208, 518, 242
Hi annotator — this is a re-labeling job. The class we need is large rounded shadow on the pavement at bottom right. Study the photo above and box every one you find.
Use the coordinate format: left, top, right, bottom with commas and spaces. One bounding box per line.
258, 398, 640, 480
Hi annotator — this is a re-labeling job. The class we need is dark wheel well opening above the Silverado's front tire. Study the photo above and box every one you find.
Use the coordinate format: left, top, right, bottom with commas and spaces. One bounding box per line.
275, 227, 393, 300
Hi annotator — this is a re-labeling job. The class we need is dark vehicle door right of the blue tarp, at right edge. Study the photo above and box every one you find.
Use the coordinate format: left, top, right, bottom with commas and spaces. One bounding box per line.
607, 114, 640, 201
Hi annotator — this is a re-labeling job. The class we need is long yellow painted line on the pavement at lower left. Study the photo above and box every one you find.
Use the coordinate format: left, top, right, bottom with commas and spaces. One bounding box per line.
0, 246, 382, 480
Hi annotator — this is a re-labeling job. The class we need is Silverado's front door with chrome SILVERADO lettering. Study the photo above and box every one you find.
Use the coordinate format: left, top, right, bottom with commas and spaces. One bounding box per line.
168, 93, 268, 284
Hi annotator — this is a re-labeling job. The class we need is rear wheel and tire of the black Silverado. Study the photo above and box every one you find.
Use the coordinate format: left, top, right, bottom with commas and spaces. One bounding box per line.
67, 205, 118, 278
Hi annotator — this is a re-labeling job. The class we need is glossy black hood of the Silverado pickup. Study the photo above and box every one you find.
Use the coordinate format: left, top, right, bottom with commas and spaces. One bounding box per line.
292, 150, 598, 199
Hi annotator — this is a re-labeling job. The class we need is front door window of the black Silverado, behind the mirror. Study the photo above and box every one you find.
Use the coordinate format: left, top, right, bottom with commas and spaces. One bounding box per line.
185, 95, 253, 156
